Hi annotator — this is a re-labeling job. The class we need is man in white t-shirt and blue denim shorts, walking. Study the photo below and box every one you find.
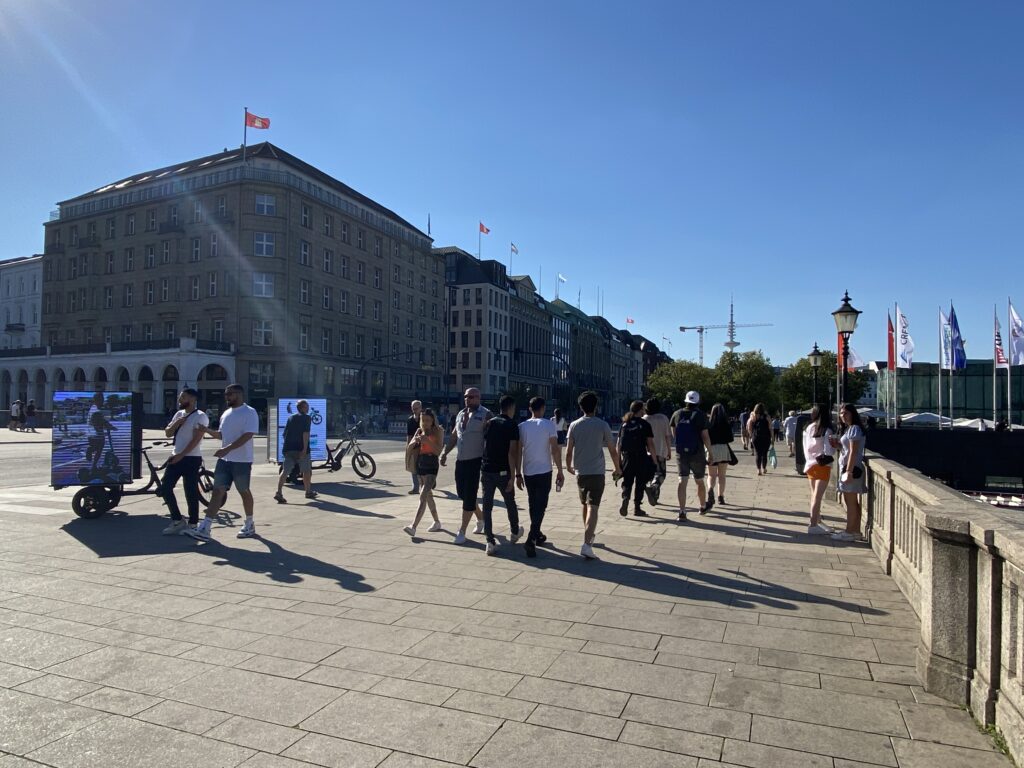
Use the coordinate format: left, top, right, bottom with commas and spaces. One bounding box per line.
185, 384, 259, 542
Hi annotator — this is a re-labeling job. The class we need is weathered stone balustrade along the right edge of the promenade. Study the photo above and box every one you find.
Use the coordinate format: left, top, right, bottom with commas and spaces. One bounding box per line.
863, 456, 1024, 764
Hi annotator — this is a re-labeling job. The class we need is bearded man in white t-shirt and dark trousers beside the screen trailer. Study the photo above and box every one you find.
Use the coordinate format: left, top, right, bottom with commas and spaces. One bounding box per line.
160, 387, 210, 536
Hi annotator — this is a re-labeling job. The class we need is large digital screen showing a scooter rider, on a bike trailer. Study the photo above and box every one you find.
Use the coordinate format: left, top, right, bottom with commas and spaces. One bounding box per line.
50, 392, 134, 487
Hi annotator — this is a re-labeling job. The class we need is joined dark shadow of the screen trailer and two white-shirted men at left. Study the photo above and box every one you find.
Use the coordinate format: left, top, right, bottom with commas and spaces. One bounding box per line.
61, 511, 374, 592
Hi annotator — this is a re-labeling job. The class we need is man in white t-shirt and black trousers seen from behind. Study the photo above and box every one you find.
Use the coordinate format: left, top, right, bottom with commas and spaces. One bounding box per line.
515, 397, 565, 557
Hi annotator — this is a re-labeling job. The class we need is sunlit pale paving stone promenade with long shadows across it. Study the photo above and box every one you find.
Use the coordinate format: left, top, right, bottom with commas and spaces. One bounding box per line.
0, 436, 1011, 768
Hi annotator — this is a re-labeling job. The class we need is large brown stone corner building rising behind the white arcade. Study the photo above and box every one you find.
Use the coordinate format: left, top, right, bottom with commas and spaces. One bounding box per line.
34, 143, 444, 418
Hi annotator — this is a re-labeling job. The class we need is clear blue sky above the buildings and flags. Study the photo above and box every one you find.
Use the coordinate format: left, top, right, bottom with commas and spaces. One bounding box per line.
0, 0, 1024, 365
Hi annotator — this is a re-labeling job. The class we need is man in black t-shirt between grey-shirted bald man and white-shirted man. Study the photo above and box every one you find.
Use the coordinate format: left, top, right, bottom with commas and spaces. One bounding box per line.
480, 395, 522, 555
